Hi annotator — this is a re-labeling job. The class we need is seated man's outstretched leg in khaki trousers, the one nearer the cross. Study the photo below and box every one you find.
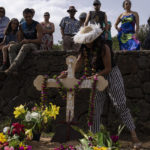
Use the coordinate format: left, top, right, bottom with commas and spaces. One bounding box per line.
8, 43, 37, 72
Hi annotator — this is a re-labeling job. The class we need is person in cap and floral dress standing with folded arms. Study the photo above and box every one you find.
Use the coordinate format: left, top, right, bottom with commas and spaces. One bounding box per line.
41, 12, 55, 50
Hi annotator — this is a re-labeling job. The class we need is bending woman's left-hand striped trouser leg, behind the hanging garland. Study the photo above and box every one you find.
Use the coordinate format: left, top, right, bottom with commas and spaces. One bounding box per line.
90, 91, 106, 133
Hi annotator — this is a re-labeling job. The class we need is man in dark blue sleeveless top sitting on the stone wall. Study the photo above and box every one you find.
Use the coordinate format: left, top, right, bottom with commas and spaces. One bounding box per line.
5, 8, 42, 73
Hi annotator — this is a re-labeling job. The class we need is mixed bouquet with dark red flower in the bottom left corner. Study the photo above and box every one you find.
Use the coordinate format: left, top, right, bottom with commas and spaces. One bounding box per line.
0, 123, 32, 150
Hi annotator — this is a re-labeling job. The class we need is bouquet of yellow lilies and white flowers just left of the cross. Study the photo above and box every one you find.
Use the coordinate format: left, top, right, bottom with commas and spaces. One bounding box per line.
14, 103, 60, 141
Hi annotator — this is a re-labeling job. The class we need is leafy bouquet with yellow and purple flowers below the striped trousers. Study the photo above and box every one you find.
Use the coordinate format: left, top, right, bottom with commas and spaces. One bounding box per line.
73, 125, 124, 150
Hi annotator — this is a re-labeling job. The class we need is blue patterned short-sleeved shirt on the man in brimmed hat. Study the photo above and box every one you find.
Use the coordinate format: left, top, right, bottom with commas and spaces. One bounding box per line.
60, 17, 80, 35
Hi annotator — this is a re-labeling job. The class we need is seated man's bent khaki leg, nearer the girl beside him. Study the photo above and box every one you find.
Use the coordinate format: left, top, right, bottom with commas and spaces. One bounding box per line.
8, 44, 21, 64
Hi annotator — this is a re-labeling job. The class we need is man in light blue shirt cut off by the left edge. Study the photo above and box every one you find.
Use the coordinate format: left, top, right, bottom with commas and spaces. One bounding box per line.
0, 7, 10, 43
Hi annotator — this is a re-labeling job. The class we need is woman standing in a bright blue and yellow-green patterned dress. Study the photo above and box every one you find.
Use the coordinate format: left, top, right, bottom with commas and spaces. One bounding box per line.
115, 0, 140, 51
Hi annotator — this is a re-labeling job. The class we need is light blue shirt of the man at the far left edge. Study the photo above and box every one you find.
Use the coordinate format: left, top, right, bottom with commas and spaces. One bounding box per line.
0, 16, 10, 38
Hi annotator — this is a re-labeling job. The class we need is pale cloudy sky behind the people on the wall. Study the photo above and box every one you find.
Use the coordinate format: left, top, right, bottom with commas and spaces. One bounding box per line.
0, 0, 150, 43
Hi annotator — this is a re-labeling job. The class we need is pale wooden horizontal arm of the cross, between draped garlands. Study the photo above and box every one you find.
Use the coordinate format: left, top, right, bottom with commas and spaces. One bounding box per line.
34, 75, 108, 91
